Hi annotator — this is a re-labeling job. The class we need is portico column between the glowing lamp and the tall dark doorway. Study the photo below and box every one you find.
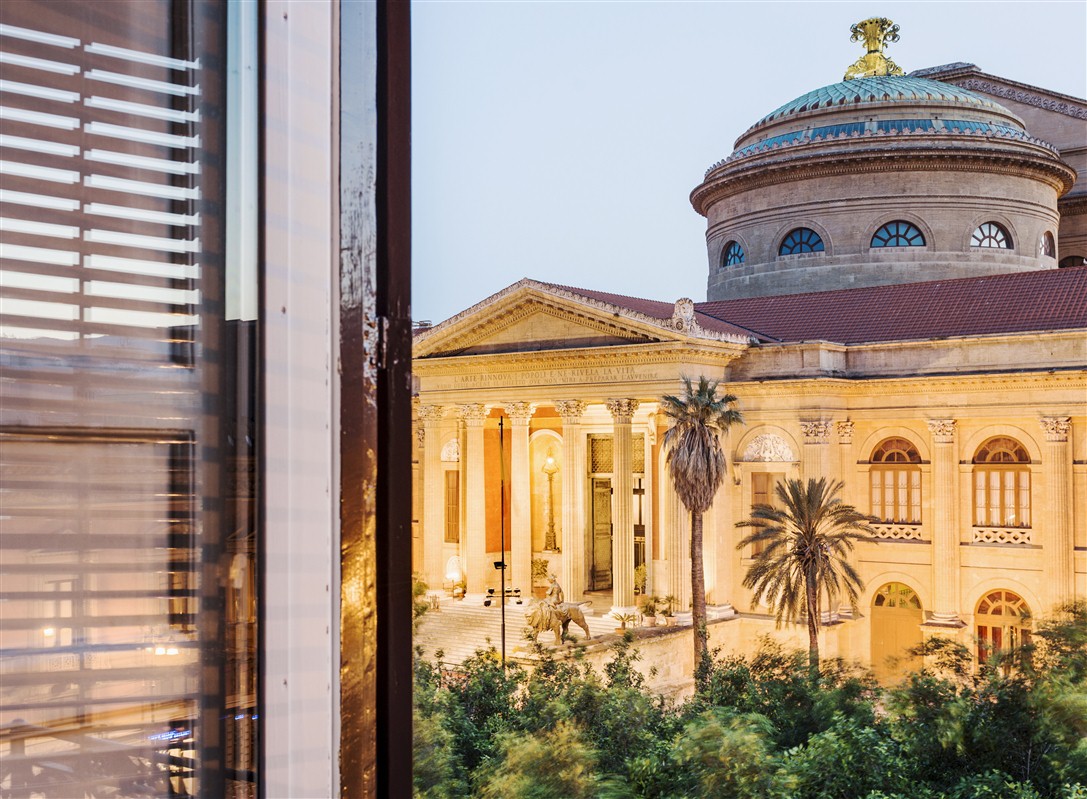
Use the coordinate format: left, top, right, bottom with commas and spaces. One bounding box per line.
554, 400, 586, 602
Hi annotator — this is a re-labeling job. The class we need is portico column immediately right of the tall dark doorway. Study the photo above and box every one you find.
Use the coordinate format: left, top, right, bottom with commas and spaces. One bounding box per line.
604, 399, 638, 612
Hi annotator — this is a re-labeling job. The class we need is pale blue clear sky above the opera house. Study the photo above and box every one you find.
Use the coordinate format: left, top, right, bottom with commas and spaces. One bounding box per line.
412, 0, 1087, 324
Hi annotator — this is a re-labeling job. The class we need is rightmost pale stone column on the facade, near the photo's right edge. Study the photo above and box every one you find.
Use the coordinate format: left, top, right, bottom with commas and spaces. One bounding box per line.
1032, 416, 1075, 611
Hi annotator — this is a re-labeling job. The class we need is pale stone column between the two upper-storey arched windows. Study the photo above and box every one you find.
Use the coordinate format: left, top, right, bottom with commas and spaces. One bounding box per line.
928, 419, 962, 627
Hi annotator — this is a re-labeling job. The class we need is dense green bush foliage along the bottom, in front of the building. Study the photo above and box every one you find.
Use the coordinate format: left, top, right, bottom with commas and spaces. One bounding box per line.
414, 603, 1087, 799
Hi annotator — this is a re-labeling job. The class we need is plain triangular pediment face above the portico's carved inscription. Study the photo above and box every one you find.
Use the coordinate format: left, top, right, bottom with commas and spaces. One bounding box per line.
416, 299, 662, 358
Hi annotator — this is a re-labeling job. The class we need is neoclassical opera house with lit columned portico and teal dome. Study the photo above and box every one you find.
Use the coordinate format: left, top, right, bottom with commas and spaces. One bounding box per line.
414, 20, 1087, 674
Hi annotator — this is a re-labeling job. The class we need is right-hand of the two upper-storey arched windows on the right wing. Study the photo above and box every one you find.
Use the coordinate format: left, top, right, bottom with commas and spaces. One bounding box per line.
974, 436, 1030, 527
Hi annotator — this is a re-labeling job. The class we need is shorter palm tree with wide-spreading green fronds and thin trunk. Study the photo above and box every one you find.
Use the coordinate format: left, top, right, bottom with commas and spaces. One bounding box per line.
736, 477, 875, 677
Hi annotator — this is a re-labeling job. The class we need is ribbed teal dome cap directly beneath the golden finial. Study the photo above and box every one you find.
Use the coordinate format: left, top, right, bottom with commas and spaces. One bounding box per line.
751, 75, 1009, 129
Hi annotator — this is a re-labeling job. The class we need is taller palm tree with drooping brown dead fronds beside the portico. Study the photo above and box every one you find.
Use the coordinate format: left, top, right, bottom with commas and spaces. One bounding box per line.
661, 377, 744, 671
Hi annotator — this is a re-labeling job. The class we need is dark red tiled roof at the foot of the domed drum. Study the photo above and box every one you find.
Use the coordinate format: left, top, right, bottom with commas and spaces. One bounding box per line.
698, 266, 1087, 344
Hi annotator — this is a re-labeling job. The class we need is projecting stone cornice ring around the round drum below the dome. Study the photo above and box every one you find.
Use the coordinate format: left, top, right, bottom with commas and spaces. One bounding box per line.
690, 140, 1076, 216
